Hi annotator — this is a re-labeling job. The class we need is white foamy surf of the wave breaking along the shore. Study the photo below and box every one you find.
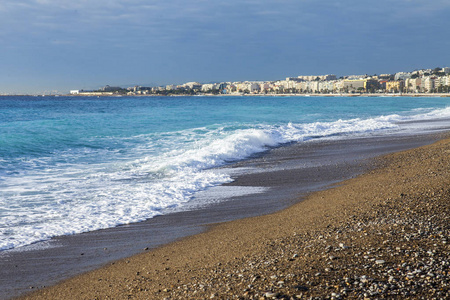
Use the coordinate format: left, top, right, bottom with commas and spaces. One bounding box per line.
0, 108, 450, 250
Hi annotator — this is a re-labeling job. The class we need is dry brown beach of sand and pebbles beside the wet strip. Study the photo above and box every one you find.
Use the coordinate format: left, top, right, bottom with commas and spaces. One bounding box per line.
20, 134, 450, 299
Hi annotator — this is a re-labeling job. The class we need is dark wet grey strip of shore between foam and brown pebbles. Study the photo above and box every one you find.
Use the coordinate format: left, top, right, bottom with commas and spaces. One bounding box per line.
0, 115, 450, 299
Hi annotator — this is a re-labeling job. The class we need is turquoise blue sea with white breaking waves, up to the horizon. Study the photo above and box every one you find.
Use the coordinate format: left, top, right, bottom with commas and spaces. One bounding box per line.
0, 96, 450, 251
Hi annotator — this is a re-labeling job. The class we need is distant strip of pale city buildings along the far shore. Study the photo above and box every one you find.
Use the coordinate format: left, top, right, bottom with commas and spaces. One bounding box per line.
70, 67, 450, 96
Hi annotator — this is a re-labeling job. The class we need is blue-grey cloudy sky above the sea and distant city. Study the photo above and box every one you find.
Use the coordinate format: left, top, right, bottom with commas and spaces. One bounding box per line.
0, 0, 450, 94
